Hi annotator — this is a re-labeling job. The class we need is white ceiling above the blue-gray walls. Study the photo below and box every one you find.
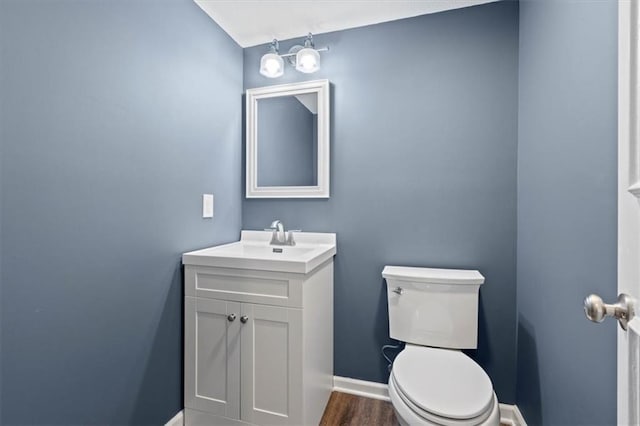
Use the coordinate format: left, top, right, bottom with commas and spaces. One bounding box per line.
195, 0, 498, 47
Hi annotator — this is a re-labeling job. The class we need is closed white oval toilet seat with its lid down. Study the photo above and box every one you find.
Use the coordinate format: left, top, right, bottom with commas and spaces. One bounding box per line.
389, 345, 497, 425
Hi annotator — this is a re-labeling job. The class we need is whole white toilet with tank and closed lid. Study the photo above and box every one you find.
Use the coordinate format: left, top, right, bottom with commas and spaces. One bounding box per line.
382, 266, 500, 426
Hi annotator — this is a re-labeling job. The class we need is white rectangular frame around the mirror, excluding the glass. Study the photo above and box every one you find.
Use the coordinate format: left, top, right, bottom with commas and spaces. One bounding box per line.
246, 80, 329, 198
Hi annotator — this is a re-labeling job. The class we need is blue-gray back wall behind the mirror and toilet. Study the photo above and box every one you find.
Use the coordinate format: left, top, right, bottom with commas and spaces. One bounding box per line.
242, 2, 518, 403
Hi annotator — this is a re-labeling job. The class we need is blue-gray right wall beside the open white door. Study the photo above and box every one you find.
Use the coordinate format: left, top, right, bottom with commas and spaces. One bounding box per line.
517, 0, 617, 425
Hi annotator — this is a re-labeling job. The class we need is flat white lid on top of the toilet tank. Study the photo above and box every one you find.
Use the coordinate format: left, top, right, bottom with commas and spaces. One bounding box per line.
382, 266, 484, 284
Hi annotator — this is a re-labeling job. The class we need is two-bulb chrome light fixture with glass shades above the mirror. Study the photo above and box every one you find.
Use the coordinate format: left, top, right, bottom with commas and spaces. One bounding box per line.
260, 33, 329, 78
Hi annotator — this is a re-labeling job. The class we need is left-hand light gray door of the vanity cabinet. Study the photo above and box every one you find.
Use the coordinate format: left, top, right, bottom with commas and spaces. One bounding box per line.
184, 297, 241, 419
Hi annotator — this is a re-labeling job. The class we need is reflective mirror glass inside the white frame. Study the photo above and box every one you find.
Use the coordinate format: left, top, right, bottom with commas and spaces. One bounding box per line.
258, 93, 318, 187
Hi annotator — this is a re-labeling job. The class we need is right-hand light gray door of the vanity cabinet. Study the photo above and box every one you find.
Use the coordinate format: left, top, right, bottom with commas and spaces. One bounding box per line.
241, 303, 303, 425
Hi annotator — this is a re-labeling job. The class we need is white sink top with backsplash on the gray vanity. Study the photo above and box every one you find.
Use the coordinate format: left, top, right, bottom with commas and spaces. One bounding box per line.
182, 231, 336, 274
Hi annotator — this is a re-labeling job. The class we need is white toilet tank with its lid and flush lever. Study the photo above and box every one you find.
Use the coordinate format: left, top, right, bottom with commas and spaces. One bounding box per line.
382, 266, 484, 349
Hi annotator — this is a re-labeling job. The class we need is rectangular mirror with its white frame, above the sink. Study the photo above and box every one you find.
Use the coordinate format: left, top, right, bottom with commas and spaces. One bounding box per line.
246, 80, 329, 198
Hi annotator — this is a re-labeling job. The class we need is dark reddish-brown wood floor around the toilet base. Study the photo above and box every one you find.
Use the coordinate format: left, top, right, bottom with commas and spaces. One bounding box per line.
320, 392, 509, 426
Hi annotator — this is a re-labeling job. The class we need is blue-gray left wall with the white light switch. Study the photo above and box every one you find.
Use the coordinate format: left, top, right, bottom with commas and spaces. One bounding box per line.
0, 0, 242, 425
